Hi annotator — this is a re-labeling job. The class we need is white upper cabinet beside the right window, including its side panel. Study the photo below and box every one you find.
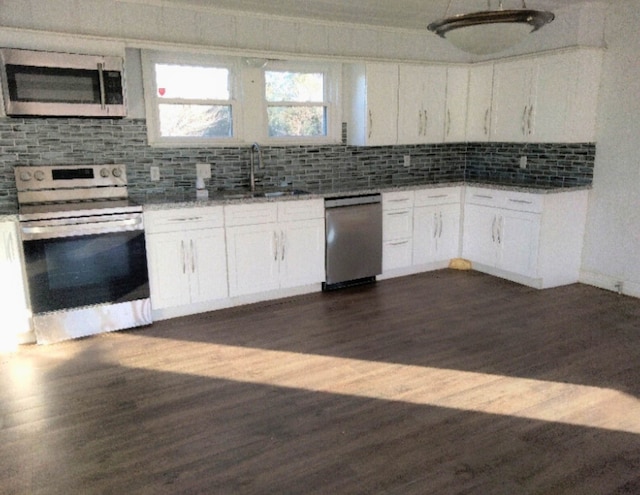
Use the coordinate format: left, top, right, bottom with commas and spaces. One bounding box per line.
347, 63, 398, 146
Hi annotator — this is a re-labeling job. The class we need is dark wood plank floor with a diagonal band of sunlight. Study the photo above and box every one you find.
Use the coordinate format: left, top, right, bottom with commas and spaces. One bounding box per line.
0, 271, 640, 495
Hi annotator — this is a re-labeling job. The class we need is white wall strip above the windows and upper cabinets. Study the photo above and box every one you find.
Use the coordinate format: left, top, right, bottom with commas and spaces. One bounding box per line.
0, 0, 604, 62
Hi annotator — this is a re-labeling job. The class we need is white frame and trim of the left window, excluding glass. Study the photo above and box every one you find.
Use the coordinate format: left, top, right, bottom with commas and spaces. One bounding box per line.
141, 50, 243, 147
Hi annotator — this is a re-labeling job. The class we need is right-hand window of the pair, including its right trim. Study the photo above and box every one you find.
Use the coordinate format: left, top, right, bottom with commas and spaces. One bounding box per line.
264, 62, 338, 142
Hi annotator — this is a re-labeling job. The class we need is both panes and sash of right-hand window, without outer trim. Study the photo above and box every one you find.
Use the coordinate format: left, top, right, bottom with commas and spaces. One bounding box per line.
265, 71, 327, 137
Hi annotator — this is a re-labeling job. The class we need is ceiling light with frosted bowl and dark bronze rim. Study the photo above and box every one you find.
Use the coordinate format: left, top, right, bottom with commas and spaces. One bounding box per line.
428, 0, 555, 55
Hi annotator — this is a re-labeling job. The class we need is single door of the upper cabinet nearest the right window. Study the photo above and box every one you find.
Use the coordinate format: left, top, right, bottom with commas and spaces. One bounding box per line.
364, 63, 398, 146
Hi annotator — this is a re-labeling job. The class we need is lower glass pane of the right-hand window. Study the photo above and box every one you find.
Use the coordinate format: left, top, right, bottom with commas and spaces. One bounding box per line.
267, 106, 327, 137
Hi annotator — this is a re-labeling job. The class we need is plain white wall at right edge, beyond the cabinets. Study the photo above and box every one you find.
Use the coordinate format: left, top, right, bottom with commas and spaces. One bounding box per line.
581, 0, 640, 297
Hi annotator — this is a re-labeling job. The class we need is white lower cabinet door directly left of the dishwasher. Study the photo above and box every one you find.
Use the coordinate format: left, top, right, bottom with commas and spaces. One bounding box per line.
279, 218, 325, 288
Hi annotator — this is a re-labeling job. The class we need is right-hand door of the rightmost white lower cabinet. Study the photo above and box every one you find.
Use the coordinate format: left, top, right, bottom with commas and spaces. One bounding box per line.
498, 210, 540, 277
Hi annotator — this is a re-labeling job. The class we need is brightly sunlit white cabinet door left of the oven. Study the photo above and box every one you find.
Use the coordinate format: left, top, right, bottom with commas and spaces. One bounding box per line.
0, 222, 30, 340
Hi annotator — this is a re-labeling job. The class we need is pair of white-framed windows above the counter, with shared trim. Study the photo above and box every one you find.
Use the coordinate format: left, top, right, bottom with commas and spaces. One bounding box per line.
142, 50, 342, 146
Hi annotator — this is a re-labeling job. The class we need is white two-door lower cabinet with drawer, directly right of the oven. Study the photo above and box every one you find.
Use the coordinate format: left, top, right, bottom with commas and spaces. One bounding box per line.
144, 207, 228, 310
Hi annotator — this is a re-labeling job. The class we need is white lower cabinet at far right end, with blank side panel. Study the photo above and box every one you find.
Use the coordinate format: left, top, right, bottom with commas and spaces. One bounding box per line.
462, 187, 587, 289
